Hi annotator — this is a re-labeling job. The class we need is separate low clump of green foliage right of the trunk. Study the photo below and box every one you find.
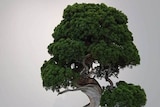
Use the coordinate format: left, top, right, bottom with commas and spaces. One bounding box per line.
101, 81, 146, 107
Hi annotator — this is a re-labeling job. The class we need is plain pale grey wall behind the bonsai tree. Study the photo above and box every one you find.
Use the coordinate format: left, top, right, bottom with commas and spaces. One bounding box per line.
0, 0, 160, 107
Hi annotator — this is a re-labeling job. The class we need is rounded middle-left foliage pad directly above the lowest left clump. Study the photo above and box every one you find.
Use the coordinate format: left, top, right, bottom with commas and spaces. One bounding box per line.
48, 38, 86, 64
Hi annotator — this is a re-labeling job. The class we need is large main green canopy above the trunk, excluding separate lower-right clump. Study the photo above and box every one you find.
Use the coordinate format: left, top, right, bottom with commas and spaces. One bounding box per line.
41, 3, 140, 90
